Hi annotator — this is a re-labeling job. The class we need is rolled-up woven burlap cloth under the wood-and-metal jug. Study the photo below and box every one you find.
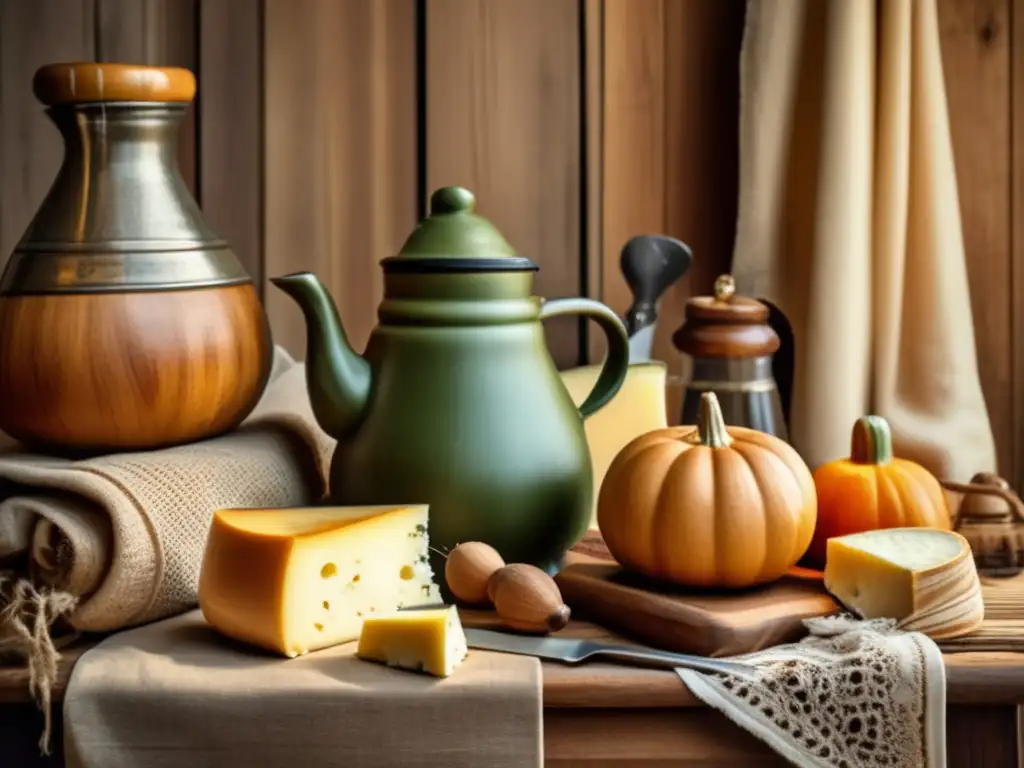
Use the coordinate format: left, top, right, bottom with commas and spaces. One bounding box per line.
0, 348, 334, 636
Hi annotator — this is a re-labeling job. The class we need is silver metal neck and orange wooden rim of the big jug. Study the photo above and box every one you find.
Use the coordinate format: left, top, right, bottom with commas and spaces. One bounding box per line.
0, 61, 252, 296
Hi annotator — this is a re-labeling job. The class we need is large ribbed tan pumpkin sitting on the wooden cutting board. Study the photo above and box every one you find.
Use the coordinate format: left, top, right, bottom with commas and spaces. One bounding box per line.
597, 392, 817, 588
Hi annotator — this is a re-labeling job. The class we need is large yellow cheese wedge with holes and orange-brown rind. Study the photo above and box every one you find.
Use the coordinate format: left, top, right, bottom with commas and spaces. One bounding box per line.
199, 505, 440, 656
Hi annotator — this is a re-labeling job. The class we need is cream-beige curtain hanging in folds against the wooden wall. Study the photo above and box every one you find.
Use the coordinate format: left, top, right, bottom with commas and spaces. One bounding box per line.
733, 0, 995, 480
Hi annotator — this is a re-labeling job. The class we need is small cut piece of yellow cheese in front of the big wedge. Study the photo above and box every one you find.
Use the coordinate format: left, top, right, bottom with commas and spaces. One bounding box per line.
355, 605, 469, 677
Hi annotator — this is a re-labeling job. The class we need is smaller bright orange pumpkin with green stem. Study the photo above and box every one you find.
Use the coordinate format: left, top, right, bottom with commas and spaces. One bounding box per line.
807, 416, 951, 567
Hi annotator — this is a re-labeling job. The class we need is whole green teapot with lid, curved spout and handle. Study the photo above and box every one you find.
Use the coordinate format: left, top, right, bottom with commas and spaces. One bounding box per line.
271, 187, 629, 573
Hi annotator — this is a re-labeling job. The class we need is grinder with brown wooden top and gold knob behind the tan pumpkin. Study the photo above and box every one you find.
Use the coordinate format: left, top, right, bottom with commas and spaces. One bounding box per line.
672, 274, 787, 440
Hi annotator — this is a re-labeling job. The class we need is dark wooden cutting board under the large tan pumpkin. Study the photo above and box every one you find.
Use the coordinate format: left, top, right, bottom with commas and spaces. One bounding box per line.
555, 558, 839, 656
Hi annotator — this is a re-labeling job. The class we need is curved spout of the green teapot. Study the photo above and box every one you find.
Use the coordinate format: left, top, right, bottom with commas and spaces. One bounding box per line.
270, 272, 372, 440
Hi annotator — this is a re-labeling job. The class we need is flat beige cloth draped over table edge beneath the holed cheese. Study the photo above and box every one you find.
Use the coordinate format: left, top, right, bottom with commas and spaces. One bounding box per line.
63, 611, 543, 768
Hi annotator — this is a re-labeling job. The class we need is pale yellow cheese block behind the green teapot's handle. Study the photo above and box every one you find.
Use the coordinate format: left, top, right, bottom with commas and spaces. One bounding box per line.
561, 362, 669, 528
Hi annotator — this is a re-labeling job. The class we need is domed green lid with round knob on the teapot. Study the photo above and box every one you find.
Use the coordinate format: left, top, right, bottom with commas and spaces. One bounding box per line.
381, 186, 538, 274
